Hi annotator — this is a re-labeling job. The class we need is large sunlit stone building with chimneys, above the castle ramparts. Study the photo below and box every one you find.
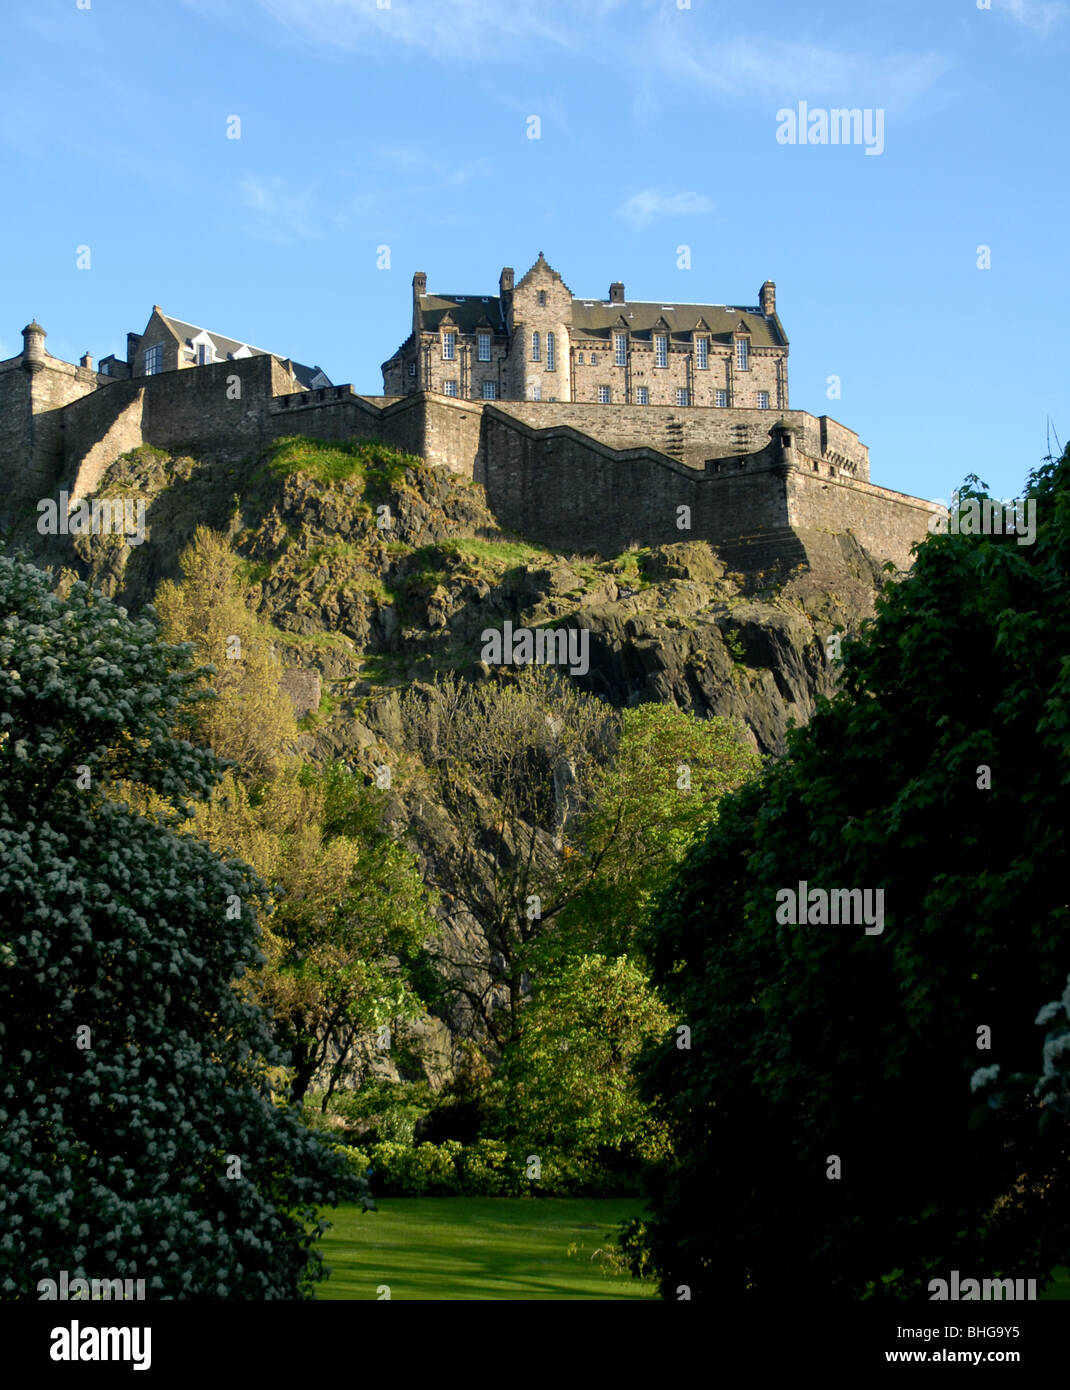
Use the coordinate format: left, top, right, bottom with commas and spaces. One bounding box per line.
382, 252, 788, 410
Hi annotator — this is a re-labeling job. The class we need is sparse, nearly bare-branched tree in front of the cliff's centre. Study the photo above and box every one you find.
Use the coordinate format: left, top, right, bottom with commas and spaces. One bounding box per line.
400, 666, 617, 1047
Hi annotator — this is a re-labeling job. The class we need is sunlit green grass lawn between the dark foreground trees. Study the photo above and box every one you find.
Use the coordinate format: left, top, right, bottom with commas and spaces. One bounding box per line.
317, 1197, 657, 1300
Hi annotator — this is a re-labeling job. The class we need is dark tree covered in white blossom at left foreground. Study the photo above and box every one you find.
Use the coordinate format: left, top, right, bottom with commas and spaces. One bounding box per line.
0, 556, 356, 1298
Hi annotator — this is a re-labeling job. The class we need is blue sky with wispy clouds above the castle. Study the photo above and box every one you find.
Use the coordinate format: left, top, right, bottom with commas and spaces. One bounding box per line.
0, 0, 1070, 498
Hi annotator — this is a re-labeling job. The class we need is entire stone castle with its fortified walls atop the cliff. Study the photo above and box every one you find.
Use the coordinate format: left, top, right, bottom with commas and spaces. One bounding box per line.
0, 254, 939, 573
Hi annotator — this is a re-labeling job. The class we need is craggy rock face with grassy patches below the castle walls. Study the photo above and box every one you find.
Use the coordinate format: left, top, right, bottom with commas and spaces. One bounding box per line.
22, 441, 885, 1077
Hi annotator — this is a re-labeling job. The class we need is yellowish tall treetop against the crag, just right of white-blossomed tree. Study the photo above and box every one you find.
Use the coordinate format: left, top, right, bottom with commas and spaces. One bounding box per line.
156, 527, 297, 776
